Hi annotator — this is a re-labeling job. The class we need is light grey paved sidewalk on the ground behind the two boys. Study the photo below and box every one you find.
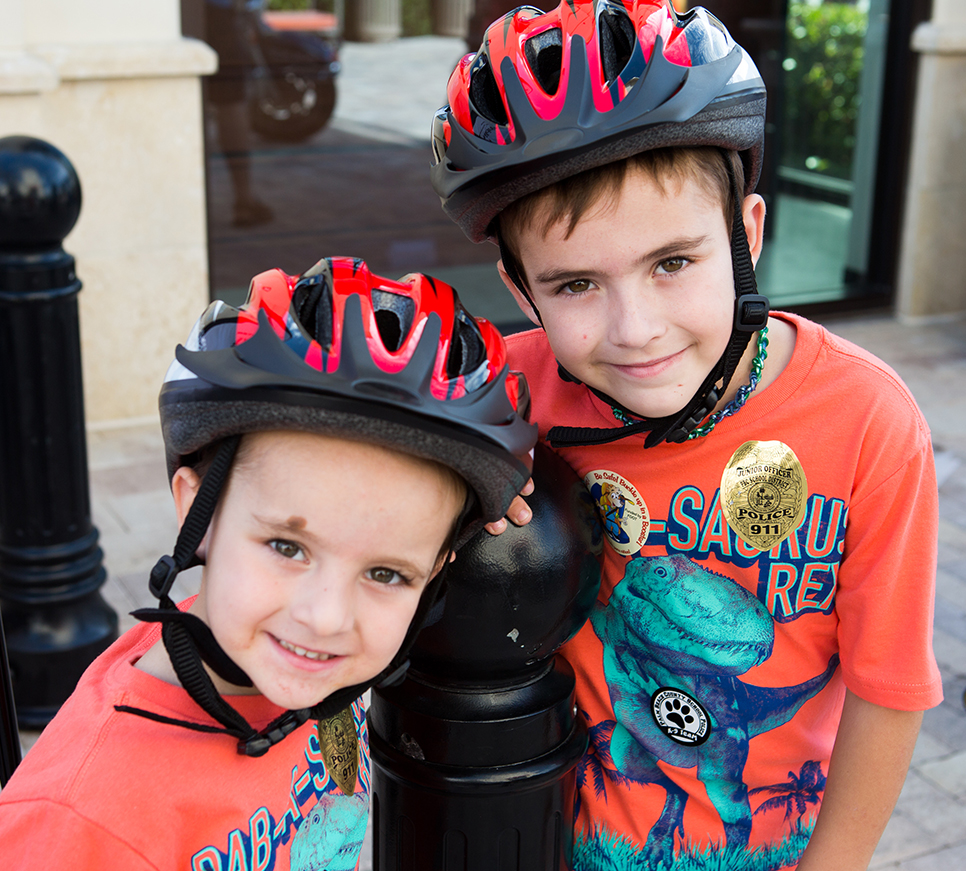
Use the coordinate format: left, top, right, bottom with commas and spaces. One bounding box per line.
9, 316, 966, 871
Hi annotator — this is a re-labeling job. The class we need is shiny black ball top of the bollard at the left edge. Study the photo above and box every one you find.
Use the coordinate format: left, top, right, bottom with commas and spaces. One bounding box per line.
0, 136, 81, 250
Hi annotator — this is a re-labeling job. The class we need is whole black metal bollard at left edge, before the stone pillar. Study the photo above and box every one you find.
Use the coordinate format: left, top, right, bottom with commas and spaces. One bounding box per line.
0, 136, 117, 729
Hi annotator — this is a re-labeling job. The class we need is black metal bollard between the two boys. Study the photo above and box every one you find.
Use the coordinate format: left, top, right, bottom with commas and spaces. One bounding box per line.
369, 445, 600, 871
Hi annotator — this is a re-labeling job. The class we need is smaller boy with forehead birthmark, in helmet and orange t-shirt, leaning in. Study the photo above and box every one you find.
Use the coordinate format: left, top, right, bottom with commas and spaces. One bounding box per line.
0, 258, 536, 871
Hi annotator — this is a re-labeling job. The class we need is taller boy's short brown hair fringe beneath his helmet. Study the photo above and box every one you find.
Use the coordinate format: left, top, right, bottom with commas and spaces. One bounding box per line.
498, 146, 745, 284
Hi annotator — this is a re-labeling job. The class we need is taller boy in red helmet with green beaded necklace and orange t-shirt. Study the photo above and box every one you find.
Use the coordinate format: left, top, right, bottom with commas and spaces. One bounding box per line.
433, 0, 942, 871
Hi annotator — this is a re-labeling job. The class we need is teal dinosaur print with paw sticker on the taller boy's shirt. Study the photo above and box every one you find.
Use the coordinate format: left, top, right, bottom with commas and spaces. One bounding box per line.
583, 556, 838, 868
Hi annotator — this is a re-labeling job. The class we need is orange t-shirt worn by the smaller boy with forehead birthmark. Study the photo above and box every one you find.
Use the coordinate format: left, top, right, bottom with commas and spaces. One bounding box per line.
0, 608, 370, 871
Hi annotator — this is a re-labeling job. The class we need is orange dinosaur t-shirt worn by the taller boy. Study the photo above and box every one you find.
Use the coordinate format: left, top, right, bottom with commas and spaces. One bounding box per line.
508, 315, 942, 871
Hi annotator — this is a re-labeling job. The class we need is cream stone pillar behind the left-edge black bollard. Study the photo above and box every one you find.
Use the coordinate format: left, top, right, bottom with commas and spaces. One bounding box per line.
0, 0, 217, 423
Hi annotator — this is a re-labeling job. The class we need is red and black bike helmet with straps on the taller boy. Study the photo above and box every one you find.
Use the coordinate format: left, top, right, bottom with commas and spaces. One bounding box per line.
432, 0, 768, 446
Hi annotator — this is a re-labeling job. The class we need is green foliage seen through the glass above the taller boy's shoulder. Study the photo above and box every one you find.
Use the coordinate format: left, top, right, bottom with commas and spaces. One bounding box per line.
782, 2, 869, 178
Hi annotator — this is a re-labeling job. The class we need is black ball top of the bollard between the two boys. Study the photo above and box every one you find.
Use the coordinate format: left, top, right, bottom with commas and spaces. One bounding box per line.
411, 443, 600, 681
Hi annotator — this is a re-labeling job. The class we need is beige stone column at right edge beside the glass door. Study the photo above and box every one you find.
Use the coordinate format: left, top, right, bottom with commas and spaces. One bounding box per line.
897, 0, 966, 321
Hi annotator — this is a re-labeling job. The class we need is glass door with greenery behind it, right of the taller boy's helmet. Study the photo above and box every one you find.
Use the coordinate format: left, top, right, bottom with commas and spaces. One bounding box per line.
694, 0, 890, 308
